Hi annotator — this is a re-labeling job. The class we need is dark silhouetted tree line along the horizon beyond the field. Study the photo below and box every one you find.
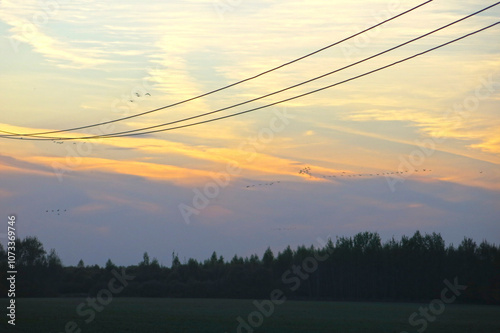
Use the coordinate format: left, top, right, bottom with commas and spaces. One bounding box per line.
0, 231, 500, 304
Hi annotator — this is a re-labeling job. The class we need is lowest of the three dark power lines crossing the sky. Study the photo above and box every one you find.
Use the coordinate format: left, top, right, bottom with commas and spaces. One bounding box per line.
5, 21, 500, 140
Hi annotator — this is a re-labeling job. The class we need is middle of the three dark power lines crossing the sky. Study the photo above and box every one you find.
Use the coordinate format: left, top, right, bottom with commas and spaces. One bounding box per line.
9, 2, 494, 139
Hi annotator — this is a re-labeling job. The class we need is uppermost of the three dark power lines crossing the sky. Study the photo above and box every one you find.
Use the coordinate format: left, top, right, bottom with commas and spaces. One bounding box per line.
0, 0, 433, 137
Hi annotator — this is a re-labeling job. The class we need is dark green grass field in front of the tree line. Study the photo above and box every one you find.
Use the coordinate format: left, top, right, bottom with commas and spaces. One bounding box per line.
0, 298, 500, 333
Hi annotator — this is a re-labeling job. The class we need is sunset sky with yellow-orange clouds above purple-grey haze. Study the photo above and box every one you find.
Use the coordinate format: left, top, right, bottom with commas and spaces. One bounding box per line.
0, 0, 500, 266
